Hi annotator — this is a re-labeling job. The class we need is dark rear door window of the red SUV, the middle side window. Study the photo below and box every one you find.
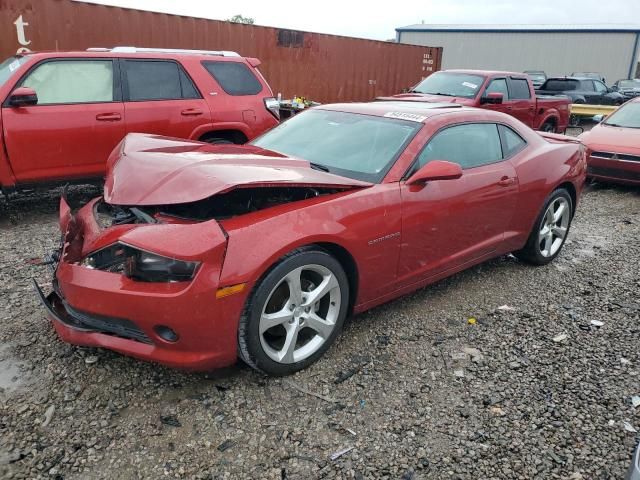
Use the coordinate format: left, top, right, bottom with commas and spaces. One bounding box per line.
124, 60, 200, 102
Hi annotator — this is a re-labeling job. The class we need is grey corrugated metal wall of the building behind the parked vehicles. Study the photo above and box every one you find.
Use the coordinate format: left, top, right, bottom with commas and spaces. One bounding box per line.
399, 32, 636, 83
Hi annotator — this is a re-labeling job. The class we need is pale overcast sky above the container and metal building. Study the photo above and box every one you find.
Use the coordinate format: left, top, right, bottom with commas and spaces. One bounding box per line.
82, 0, 640, 40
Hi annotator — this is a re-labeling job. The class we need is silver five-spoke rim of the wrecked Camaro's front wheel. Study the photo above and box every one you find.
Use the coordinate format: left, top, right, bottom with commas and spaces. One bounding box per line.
259, 264, 342, 363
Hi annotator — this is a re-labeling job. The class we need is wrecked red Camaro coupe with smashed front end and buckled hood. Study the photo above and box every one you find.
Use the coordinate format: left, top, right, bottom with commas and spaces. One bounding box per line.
36, 101, 586, 375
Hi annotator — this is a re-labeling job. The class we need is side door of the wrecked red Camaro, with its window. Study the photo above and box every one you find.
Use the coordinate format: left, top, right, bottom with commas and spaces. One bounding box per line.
398, 123, 518, 287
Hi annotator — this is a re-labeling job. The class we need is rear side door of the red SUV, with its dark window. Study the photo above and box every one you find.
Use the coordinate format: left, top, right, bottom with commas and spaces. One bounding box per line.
121, 59, 211, 138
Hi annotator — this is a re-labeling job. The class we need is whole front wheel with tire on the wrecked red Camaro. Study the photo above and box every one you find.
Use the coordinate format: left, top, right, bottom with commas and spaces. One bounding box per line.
238, 248, 349, 375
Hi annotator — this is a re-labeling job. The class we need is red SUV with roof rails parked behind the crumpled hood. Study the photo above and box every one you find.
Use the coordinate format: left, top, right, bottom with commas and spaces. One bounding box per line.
0, 47, 278, 193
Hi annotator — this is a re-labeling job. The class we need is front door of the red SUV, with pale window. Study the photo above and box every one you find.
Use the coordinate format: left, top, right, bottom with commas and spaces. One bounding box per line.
2, 58, 125, 183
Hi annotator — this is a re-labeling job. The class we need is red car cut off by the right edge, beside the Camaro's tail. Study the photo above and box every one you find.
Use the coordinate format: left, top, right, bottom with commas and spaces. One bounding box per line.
580, 98, 640, 185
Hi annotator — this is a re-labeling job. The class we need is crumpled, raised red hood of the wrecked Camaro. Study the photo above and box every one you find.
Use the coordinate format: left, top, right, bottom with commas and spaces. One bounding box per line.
104, 133, 371, 206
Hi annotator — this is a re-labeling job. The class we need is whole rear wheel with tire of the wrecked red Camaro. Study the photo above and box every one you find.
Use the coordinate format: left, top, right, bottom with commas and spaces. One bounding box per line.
513, 188, 573, 265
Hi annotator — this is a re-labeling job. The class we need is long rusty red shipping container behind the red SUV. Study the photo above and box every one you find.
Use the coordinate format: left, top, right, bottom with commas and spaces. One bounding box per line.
0, 0, 442, 103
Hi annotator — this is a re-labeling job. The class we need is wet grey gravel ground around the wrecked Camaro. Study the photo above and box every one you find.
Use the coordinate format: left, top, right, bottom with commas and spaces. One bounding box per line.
0, 181, 640, 480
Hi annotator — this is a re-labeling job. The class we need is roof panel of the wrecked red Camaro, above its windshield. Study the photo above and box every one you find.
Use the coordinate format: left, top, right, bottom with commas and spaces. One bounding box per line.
314, 100, 500, 123
